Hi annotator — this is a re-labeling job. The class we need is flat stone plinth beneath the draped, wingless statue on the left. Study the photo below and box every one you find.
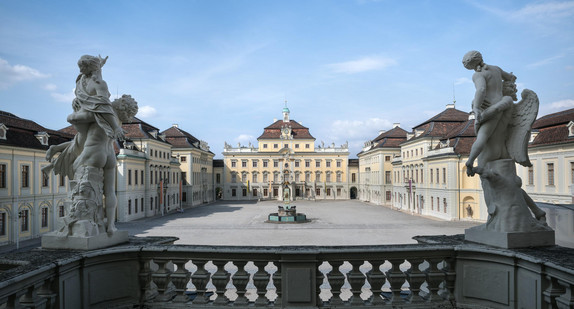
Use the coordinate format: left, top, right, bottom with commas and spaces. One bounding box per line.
42, 231, 128, 250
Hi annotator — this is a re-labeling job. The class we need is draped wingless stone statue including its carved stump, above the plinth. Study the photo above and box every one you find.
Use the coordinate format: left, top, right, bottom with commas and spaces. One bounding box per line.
41, 55, 138, 248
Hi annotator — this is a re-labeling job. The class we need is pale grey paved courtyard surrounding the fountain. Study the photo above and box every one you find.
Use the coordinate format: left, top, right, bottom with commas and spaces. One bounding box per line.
117, 201, 480, 246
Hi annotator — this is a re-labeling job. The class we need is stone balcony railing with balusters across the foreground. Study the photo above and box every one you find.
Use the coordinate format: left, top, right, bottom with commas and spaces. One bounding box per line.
0, 237, 574, 308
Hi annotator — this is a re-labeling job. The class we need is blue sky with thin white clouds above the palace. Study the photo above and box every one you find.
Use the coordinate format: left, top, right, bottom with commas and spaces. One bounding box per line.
0, 0, 574, 158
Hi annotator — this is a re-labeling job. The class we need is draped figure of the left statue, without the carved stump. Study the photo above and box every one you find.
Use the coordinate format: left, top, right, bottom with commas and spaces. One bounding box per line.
46, 55, 137, 235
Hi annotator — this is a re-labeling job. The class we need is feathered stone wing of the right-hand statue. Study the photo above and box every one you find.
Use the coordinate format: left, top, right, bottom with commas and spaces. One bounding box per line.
506, 89, 539, 166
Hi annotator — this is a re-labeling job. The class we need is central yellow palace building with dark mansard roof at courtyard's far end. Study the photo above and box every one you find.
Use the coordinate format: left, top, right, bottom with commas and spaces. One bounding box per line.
223, 107, 351, 200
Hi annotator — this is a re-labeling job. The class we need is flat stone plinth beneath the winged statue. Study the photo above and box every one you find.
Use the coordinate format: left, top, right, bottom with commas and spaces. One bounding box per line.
464, 225, 555, 249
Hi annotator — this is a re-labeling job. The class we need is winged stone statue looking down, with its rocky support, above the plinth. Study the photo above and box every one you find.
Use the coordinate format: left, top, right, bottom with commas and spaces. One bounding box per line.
462, 51, 553, 247
